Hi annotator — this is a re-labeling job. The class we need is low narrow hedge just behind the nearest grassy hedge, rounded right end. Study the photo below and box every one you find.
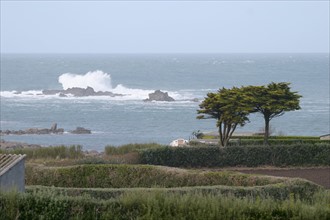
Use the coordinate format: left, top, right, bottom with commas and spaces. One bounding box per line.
26, 178, 324, 200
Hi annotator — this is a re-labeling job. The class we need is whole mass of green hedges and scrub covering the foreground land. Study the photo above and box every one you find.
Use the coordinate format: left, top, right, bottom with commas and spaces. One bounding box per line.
0, 136, 330, 219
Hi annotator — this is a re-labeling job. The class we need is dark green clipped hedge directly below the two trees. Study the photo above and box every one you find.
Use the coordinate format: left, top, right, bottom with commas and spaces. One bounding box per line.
140, 144, 330, 167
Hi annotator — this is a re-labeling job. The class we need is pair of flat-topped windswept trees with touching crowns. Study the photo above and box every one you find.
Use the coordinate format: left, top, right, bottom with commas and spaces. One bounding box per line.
197, 82, 301, 147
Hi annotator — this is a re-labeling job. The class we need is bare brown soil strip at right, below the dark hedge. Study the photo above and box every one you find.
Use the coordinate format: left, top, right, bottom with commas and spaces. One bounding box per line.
234, 167, 330, 189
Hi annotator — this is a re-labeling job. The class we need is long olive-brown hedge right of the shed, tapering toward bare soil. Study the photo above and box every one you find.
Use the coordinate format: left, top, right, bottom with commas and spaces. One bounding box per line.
26, 164, 286, 188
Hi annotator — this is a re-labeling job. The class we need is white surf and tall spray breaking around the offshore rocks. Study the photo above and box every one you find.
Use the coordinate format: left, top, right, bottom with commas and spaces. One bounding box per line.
0, 70, 199, 101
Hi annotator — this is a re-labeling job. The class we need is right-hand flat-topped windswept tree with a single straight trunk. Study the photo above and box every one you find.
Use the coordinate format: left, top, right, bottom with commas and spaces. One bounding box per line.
243, 82, 302, 145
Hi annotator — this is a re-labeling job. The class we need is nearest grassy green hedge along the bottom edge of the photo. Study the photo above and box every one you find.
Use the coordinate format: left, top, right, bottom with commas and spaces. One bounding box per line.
0, 189, 330, 220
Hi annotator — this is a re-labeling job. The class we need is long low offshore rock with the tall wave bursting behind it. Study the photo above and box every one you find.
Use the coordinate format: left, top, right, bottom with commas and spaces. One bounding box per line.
42, 86, 123, 97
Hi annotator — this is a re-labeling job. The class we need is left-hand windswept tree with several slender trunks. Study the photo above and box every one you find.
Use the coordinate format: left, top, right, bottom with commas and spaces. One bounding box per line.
197, 87, 252, 147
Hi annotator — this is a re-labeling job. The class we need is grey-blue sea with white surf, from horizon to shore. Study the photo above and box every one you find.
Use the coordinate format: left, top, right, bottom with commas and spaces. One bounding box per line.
0, 54, 330, 151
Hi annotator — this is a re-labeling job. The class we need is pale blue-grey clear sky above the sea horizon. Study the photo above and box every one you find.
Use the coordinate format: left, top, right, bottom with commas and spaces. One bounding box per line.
0, 0, 329, 53
